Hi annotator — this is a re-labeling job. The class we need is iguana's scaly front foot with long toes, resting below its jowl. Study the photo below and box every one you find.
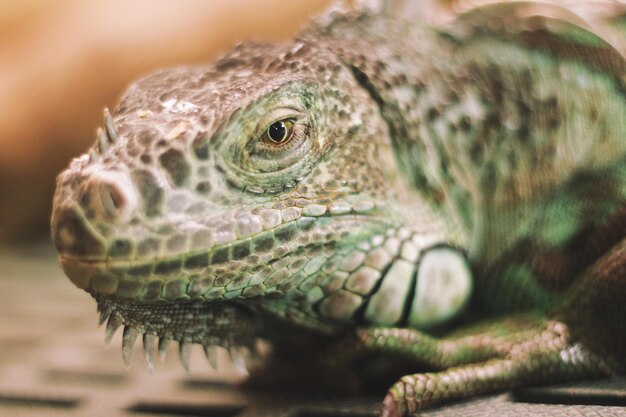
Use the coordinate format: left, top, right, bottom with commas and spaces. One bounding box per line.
324, 315, 606, 417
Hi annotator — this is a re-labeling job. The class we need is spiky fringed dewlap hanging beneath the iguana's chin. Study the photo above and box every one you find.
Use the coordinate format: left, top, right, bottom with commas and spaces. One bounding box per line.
92, 294, 259, 370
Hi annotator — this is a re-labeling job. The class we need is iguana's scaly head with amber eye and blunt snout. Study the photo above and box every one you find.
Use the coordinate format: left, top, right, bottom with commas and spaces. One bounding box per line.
52, 42, 398, 362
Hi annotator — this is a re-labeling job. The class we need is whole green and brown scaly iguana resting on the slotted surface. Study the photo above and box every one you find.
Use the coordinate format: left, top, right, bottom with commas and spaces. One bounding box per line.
51, 2, 626, 416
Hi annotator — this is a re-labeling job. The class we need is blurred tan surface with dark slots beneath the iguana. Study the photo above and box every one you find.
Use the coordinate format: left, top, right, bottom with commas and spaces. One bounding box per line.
0, 245, 626, 417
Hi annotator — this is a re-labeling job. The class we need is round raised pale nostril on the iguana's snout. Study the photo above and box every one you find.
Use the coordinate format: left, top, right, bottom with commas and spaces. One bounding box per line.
88, 172, 137, 223
